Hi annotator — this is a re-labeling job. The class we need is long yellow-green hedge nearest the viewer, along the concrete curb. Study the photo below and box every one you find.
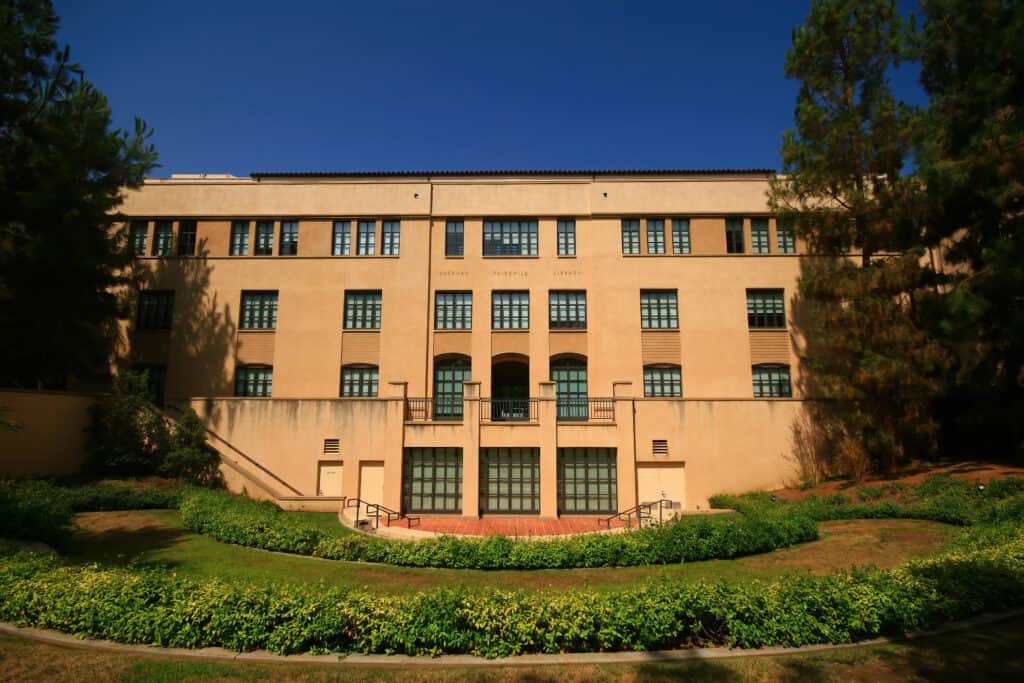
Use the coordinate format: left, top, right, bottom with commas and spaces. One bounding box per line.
0, 535, 1024, 656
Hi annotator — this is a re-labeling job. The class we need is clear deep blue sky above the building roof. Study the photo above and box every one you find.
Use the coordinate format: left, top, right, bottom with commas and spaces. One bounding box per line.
54, 0, 921, 176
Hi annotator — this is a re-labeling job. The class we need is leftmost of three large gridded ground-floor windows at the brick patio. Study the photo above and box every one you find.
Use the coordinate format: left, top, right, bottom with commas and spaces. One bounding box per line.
401, 447, 462, 513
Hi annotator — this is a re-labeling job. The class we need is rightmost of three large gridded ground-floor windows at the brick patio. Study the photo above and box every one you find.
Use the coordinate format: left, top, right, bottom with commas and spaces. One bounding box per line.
557, 449, 618, 514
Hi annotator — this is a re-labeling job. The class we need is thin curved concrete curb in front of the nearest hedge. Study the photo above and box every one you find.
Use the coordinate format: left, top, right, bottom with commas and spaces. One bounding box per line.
0, 609, 1024, 669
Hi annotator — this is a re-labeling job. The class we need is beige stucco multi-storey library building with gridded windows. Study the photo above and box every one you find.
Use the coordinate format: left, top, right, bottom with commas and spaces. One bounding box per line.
121, 170, 802, 517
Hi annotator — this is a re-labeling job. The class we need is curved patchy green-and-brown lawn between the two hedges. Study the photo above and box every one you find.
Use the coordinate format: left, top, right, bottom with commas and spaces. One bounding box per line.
68, 510, 956, 593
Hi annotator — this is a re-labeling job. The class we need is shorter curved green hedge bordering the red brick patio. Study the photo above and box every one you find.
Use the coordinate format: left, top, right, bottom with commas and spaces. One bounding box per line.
180, 490, 818, 569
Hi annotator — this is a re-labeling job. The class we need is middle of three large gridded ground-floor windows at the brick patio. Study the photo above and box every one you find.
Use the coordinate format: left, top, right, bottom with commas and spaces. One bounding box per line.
480, 447, 541, 514
